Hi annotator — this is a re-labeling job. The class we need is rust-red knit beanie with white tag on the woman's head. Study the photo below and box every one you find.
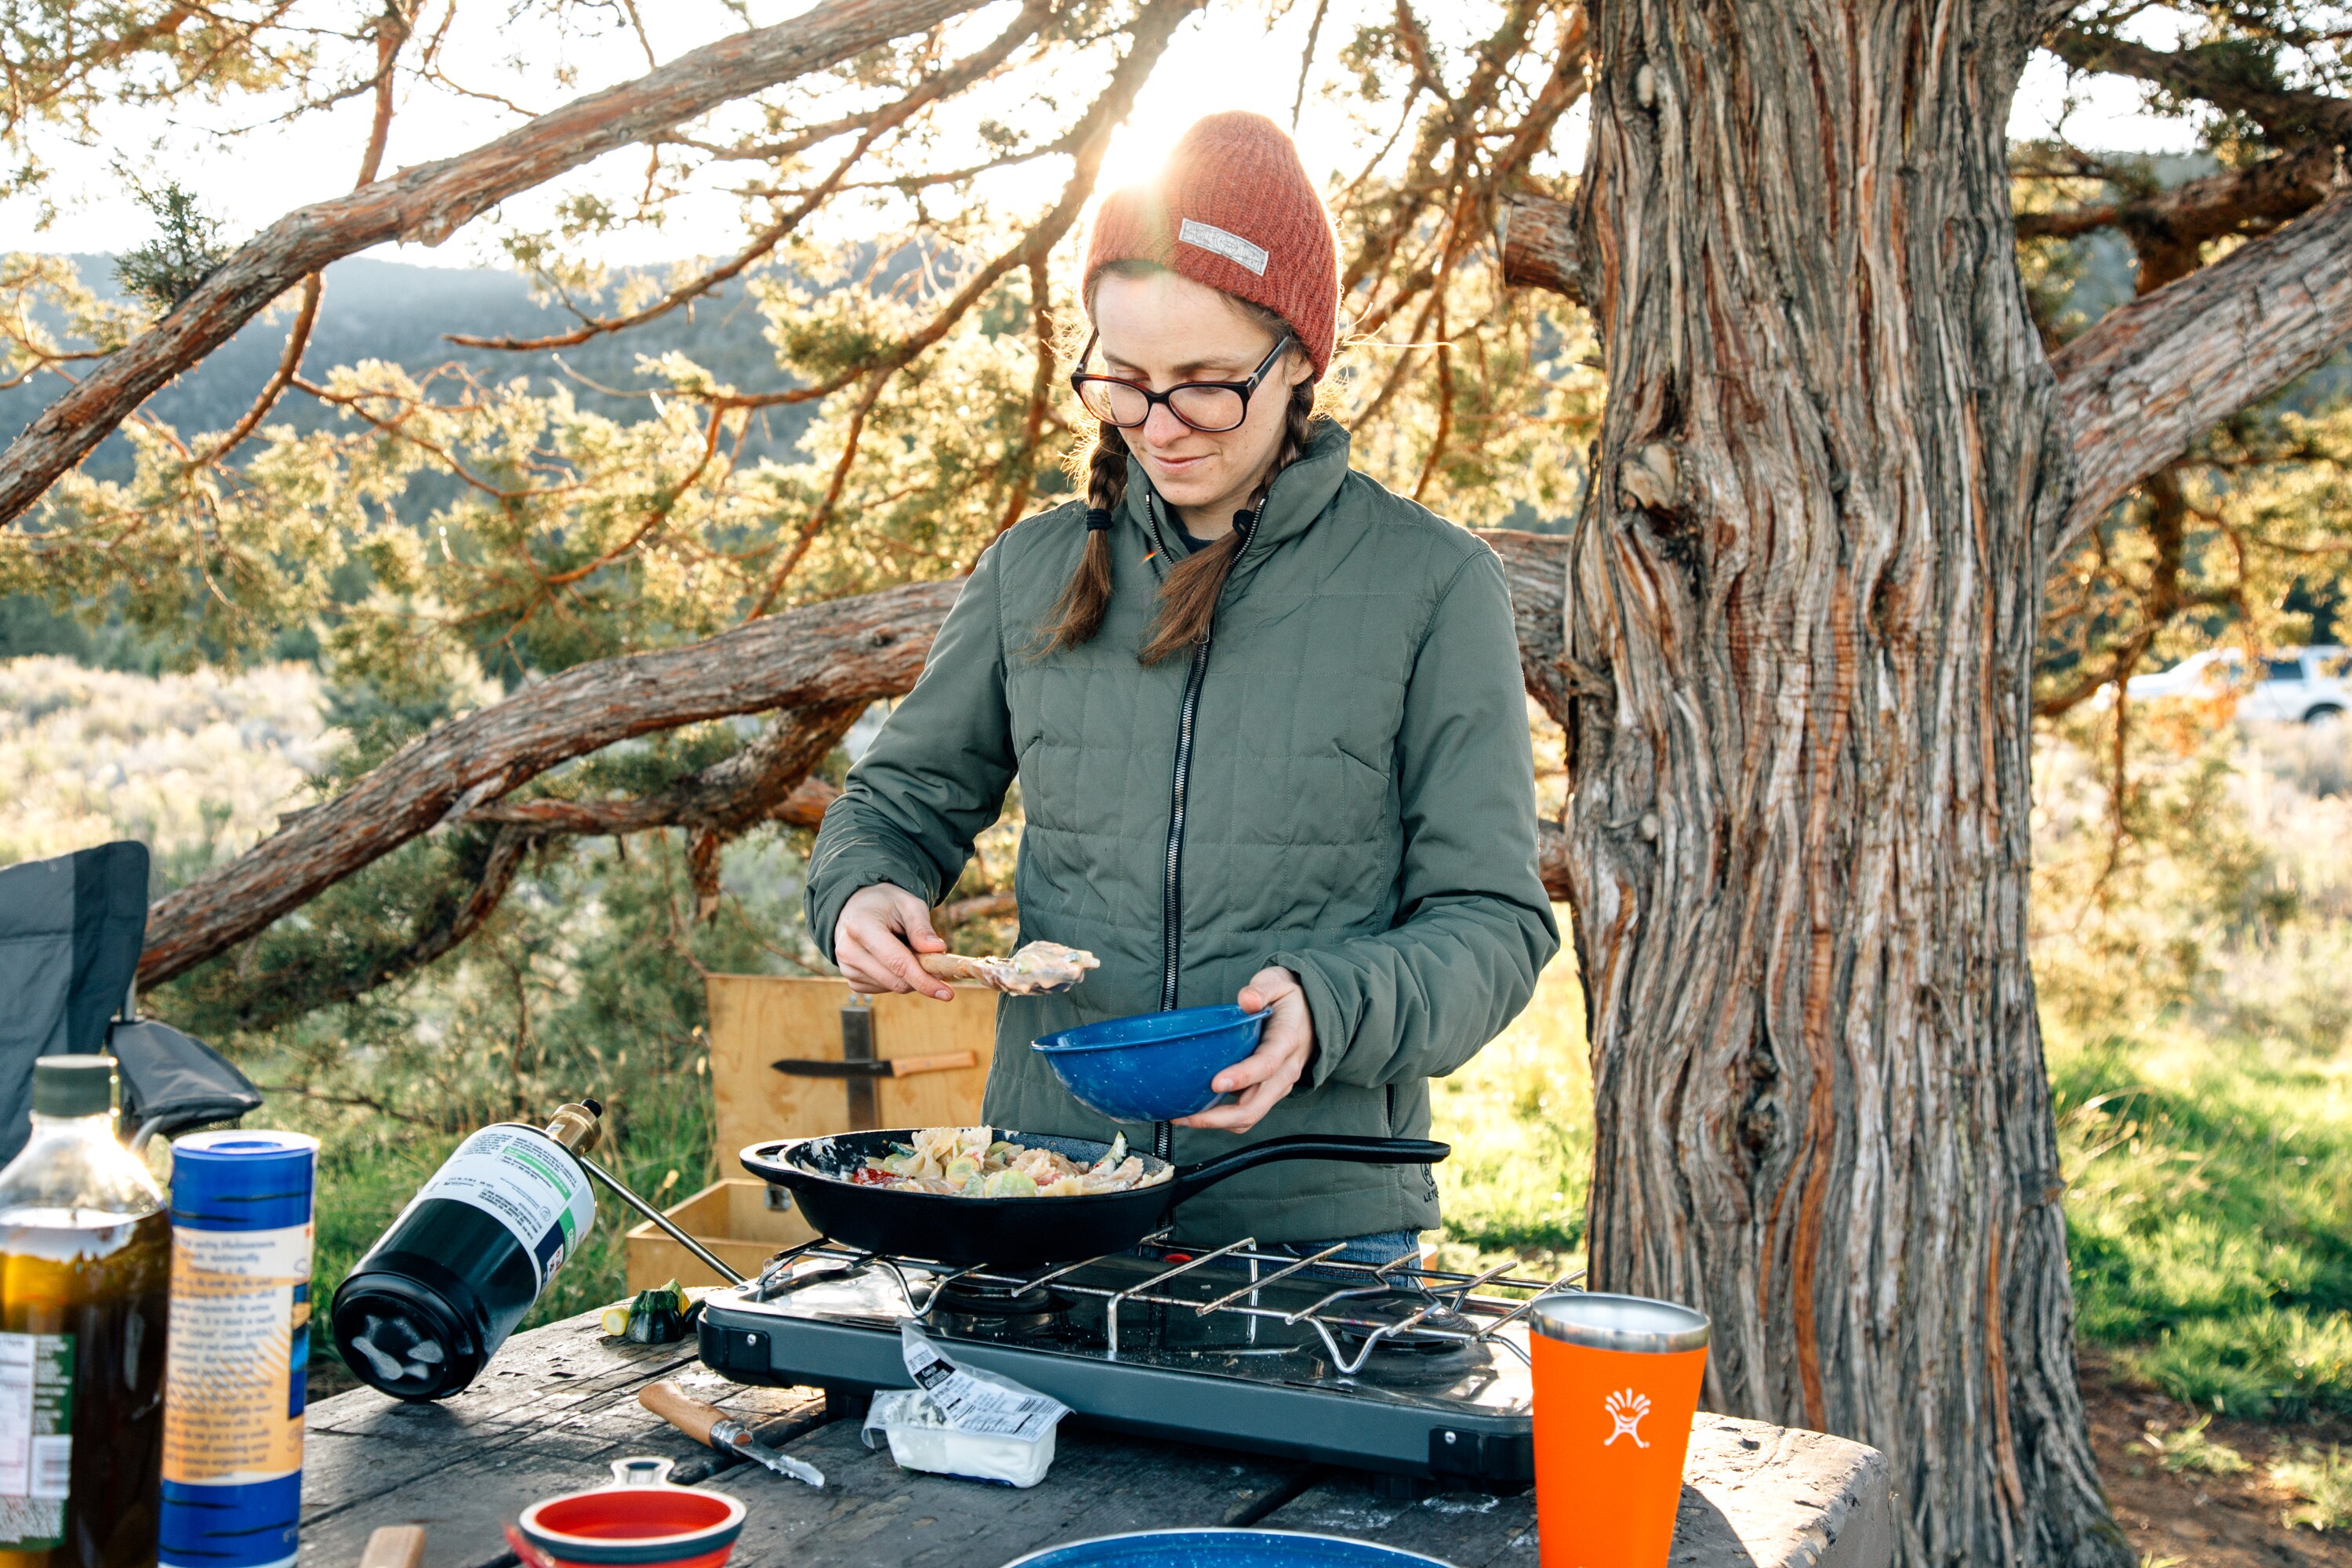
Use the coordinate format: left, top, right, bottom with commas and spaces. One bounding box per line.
1084, 111, 1338, 379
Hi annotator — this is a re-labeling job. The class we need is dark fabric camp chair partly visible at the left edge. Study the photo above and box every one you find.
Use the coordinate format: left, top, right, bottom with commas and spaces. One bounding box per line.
0, 841, 261, 1161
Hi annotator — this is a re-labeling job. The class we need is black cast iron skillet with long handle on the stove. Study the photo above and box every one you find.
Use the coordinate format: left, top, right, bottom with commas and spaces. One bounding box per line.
743, 1128, 1454, 1267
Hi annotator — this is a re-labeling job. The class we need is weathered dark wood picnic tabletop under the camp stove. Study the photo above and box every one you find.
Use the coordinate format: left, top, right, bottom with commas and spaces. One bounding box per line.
301, 1314, 1893, 1568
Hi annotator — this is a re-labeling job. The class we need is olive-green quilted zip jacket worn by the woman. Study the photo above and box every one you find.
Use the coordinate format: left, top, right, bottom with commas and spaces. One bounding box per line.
809, 423, 1559, 1243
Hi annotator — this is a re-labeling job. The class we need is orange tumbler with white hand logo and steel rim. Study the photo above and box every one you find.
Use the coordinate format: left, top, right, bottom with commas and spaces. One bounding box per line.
1526, 1290, 1708, 1568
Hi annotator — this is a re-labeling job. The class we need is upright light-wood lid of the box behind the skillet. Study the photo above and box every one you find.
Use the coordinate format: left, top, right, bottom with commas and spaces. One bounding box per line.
696, 975, 997, 1166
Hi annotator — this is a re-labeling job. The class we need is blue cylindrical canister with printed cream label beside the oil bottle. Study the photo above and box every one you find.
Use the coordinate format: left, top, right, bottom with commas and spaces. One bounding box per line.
155, 1131, 318, 1568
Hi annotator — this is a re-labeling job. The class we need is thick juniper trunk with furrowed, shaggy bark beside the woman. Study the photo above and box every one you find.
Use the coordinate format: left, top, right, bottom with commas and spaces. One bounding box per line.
1564, 0, 2129, 1566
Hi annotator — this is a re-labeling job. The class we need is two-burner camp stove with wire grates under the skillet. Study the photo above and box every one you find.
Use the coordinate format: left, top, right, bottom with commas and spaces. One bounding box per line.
701, 1236, 1576, 1490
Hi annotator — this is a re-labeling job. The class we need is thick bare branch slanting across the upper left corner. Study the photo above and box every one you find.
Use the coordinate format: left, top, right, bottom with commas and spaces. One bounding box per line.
0, 0, 978, 524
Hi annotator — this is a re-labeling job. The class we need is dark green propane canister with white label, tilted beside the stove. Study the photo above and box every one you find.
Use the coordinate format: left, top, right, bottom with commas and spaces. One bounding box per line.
329, 1100, 604, 1399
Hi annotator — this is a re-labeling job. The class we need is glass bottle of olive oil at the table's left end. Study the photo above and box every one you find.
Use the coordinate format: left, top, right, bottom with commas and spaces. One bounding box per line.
0, 1055, 172, 1568
